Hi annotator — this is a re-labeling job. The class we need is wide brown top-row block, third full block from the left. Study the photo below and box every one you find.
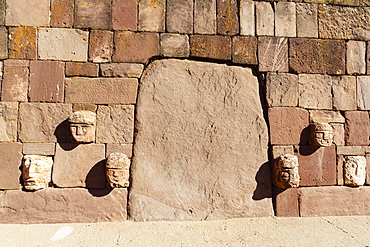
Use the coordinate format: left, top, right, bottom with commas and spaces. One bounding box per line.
74, 0, 112, 29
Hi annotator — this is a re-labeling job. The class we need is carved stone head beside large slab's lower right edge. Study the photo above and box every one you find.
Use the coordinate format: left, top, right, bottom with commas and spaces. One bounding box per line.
274, 154, 300, 189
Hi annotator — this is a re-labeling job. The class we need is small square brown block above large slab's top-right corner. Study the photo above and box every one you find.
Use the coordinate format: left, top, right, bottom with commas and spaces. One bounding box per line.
232, 36, 258, 64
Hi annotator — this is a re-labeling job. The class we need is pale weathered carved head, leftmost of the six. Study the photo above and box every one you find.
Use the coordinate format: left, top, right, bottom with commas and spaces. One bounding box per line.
22, 155, 53, 190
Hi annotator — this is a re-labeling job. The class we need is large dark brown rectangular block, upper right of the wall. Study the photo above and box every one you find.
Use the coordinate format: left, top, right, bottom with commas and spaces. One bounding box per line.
289, 38, 346, 75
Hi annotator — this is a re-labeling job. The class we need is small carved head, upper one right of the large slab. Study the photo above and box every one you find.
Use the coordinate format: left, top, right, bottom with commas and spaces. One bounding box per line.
310, 123, 333, 147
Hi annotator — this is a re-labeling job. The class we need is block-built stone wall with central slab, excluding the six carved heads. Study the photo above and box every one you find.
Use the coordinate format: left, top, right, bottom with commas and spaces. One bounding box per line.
0, 0, 370, 223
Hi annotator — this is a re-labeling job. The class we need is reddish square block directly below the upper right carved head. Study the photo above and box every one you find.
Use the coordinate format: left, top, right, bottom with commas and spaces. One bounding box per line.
296, 145, 337, 186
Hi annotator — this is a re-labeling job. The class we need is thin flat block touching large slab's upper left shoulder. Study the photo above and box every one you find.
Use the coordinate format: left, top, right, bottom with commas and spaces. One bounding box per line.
100, 63, 144, 78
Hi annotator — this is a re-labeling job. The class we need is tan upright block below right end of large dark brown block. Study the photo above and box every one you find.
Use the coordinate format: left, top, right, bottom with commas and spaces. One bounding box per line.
331, 76, 357, 111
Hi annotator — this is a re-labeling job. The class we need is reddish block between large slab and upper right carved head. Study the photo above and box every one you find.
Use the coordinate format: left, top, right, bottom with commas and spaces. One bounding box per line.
268, 107, 309, 145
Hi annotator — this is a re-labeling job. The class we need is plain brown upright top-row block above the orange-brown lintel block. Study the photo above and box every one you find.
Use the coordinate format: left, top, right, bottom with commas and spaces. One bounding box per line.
194, 0, 216, 34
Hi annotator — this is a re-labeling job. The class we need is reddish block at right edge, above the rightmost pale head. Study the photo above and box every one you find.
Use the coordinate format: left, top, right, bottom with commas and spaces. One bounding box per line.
344, 111, 370, 146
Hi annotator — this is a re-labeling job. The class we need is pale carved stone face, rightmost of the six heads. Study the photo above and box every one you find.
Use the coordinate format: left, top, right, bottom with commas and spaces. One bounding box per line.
344, 156, 366, 186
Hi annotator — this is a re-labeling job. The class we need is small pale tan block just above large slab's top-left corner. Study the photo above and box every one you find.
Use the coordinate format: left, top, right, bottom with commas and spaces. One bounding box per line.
160, 33, 190, 57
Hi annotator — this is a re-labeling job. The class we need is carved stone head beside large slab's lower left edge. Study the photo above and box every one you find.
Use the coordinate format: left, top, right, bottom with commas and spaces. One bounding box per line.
106, 153, 130, 188
